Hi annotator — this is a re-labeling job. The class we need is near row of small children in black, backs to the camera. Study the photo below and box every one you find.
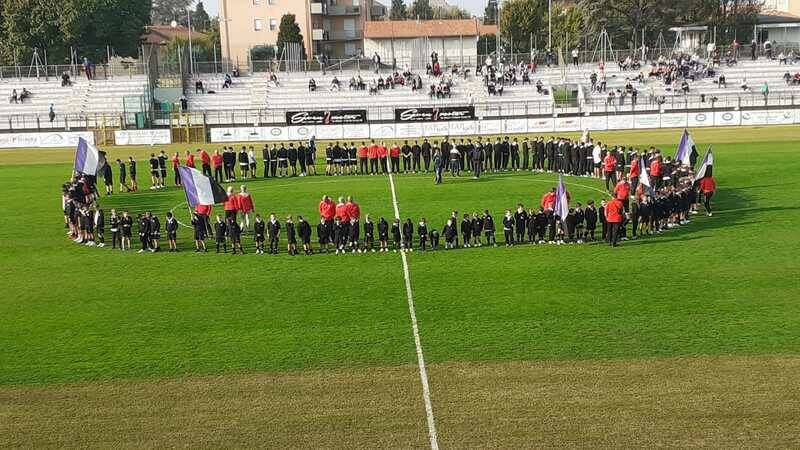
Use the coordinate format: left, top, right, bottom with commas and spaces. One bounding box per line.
72, 189, 695, 255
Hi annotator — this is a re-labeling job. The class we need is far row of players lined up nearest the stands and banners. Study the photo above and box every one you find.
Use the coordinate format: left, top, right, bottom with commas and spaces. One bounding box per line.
102, 136, 697, 194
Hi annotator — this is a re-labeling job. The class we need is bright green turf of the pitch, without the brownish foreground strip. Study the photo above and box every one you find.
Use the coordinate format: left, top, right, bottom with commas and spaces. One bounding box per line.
0, 127, 800, 386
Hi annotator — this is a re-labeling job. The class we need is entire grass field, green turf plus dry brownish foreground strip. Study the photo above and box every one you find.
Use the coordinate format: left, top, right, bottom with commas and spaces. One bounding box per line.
0, 127, 800, 448
